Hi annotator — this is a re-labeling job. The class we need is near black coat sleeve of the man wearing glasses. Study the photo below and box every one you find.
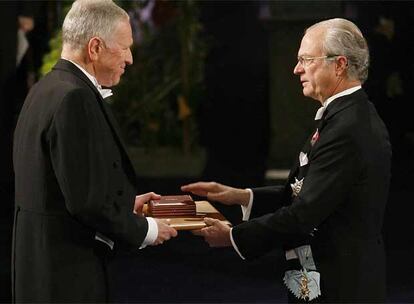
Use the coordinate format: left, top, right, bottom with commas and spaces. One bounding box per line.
233, 123, 361, 258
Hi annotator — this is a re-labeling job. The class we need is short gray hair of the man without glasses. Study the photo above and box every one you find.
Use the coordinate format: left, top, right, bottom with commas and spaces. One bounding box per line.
62, 0, 129, 50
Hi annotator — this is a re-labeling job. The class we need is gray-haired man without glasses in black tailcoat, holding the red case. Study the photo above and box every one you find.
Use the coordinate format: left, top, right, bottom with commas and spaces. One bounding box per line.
12, 0, 177, 303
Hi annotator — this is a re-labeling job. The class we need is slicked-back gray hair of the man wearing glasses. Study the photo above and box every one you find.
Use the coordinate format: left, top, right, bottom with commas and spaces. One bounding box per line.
306, 18, 369, 83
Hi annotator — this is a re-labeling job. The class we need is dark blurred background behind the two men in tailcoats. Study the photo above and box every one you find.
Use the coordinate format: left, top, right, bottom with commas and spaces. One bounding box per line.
0, 0, 414, 303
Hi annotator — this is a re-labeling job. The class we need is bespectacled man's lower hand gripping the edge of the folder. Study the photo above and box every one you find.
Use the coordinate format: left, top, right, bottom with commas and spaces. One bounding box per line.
193, 217, 232, 247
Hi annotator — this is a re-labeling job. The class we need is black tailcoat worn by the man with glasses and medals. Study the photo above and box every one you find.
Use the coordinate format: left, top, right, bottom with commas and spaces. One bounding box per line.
233, 90, 391, 302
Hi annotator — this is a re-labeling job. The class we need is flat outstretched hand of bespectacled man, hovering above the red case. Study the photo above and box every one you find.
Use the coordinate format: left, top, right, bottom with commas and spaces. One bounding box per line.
181, 182, 250, 206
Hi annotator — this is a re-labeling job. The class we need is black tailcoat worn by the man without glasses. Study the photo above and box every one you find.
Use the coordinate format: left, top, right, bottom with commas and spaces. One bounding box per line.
12, 60, 148, 303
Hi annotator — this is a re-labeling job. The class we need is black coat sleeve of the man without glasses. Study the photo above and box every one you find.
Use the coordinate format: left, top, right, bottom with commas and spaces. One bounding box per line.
48, 89, 148, 248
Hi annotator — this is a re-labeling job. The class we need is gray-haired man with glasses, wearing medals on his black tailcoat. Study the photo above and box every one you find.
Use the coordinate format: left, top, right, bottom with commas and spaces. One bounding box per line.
182, 18, 391, 303
